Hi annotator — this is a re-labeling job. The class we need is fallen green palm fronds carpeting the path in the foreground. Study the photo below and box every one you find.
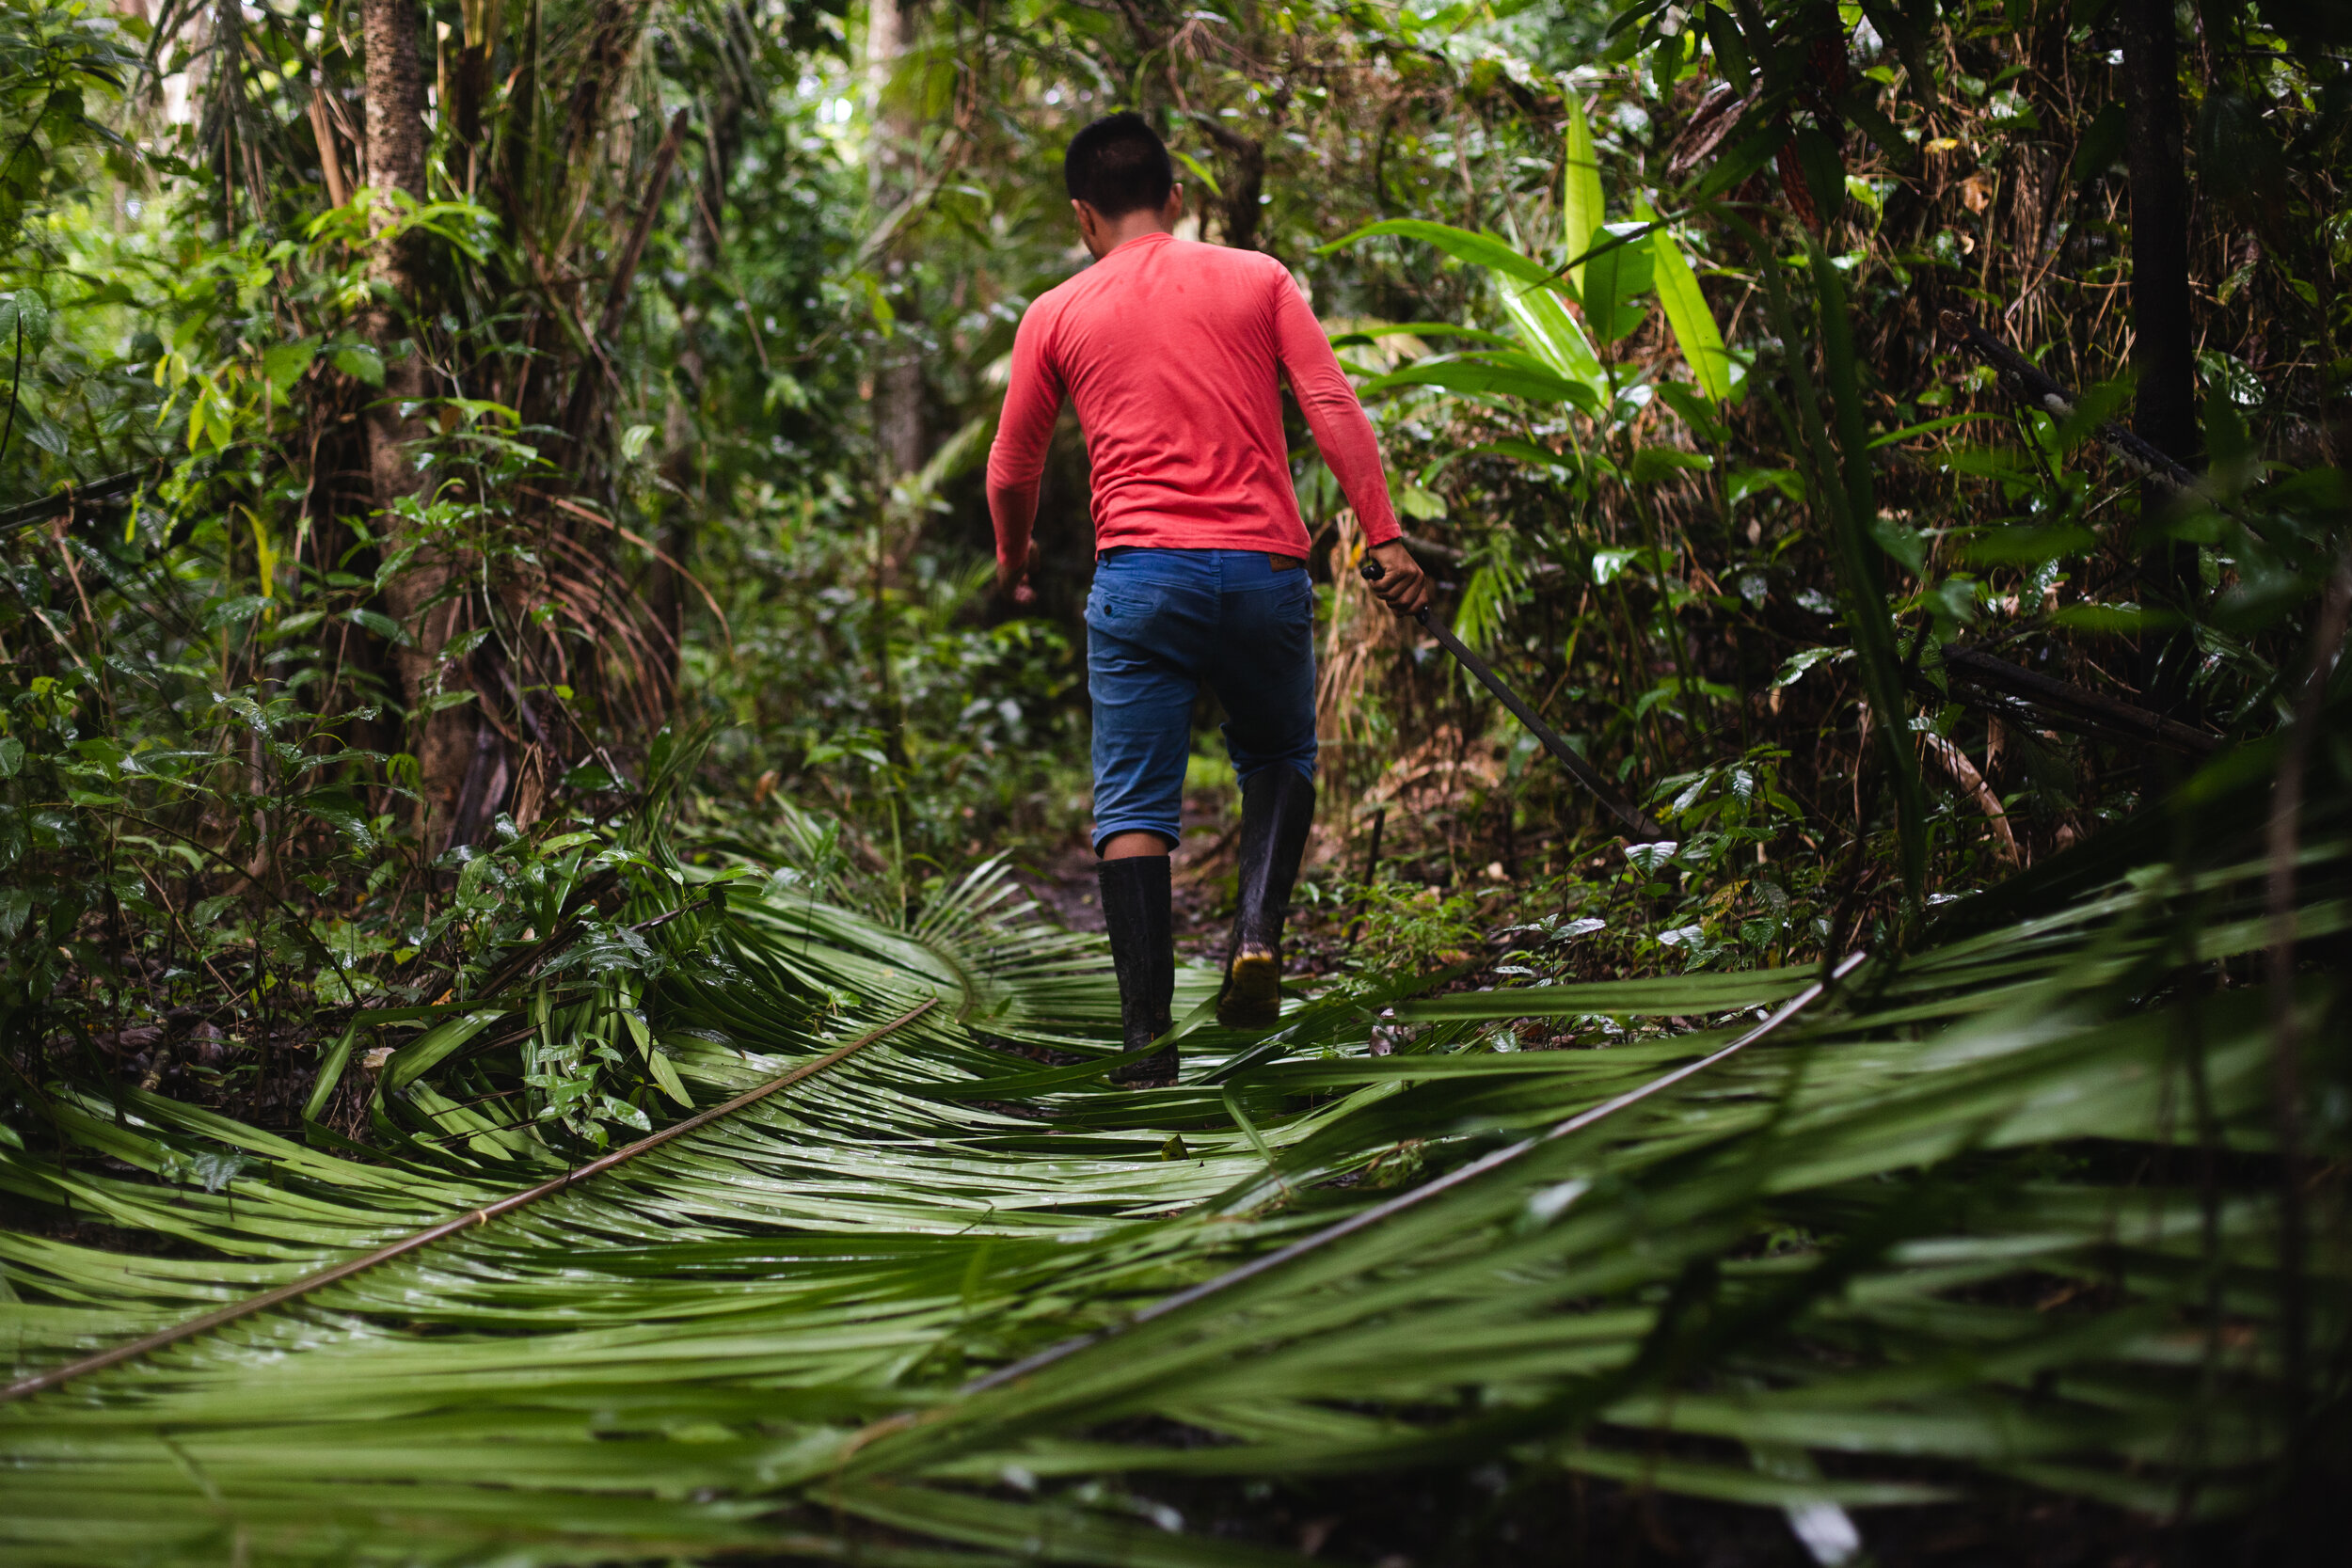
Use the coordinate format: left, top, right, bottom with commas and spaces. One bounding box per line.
0, 690, 2352, 1563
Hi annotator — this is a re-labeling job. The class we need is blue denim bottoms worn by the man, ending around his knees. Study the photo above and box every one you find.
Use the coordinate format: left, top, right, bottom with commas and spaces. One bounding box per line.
1087, 547, 1315, 851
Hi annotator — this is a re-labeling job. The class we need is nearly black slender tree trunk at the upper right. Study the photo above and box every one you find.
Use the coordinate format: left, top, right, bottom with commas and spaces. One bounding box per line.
2117, 0, 2200, 712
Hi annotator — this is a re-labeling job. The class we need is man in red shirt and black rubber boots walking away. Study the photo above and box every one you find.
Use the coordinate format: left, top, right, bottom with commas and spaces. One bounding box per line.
988, 113, 1430, 1084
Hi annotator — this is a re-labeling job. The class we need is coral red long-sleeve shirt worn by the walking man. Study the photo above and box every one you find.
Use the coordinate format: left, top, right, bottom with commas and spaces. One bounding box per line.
988, 235, 1397, 566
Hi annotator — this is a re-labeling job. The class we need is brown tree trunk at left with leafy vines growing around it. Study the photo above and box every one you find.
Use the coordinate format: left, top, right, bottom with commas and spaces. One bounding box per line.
360, 0, 473, 853
